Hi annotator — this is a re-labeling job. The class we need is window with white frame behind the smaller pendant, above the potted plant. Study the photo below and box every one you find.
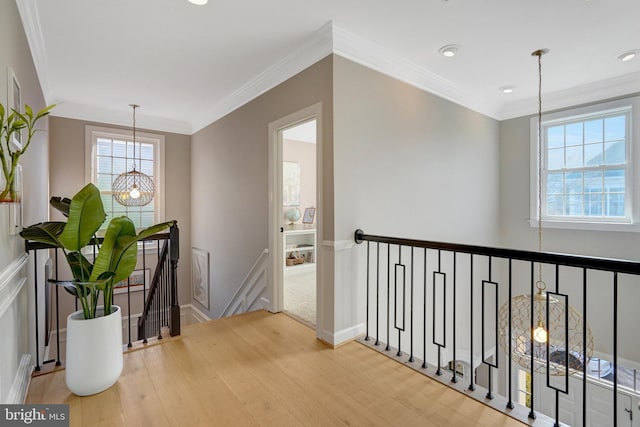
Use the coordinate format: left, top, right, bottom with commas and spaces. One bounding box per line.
85, 126, 164, 229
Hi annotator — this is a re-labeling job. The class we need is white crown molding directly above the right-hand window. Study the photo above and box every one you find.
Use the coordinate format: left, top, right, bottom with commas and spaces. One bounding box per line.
496, 72, 640, 120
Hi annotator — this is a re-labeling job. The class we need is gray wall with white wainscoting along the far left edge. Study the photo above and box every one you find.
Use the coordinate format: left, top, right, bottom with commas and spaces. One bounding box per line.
0, 1, 49, 403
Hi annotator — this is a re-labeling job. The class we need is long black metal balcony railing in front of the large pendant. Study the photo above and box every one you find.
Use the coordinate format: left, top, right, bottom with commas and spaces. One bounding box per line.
355, 230, 640, 426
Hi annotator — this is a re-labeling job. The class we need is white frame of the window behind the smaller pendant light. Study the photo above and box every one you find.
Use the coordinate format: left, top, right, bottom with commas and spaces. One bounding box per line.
84, 125, 165, 229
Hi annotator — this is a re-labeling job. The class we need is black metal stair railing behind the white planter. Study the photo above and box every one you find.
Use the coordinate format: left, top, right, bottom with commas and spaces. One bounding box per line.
25, 222, 180, 372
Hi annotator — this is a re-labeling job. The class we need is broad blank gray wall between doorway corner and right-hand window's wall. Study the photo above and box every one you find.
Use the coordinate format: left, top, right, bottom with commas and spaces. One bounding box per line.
329, 56, 499, 344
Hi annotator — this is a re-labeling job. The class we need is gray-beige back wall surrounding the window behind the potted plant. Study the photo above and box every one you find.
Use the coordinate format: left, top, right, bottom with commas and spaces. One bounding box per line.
48, 117, 191, 320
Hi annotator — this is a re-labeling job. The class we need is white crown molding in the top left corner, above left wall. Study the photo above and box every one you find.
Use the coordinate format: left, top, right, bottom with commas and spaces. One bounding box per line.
16, 0, 50, 101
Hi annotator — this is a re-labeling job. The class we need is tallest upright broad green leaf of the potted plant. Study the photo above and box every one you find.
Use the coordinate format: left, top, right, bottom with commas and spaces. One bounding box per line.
59, 184, 107, 251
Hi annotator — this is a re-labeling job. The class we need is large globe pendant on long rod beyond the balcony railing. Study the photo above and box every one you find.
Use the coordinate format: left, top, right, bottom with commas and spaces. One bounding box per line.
498, 49, 593, 375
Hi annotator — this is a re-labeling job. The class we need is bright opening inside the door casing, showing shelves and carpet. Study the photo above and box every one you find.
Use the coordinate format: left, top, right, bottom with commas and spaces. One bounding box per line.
281, 118, 317, 326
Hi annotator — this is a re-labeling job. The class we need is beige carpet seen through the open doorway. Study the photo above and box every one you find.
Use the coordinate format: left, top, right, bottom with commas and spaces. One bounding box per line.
284, 268, 316, 325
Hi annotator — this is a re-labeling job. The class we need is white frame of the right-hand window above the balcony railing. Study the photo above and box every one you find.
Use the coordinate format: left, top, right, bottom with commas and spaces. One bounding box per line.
529, 96, 640, 232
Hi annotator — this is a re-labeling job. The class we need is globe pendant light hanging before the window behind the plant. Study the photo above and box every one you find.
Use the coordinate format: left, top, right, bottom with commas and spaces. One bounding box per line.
112, 104, 156, 206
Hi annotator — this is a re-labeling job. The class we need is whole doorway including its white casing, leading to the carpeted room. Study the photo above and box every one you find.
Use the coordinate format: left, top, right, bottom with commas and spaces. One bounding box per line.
265, 103, 325, 337
